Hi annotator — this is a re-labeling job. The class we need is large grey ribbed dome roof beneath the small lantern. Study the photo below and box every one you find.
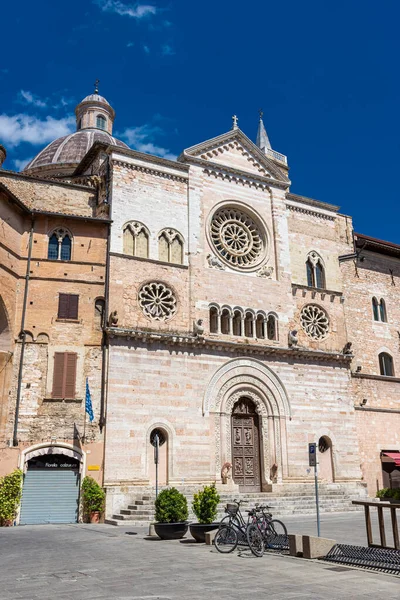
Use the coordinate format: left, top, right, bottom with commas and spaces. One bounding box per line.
24, 129, 129, 174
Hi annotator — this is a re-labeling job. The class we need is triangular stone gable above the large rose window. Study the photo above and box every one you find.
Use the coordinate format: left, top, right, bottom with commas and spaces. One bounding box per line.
180, 129, 288, 181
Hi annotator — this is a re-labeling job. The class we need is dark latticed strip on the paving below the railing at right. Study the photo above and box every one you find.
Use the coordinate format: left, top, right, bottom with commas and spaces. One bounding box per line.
322, 544, 400, 575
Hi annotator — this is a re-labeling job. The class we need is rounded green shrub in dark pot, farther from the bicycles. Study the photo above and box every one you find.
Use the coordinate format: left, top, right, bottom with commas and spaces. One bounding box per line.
154, 488, 188, 540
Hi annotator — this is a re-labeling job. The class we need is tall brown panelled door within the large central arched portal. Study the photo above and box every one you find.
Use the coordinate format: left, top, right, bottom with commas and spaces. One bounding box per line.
231, 397, 261, 492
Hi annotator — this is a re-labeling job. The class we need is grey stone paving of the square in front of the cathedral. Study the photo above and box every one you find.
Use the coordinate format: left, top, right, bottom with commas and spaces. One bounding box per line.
0, 513, 400, 600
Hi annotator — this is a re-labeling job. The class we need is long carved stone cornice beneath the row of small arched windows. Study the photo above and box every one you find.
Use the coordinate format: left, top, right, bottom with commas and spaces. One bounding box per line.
105, 327, 353, 365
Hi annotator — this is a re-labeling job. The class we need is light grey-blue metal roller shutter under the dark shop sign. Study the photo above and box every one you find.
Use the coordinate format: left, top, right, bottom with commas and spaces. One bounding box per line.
20, 469, 80, 525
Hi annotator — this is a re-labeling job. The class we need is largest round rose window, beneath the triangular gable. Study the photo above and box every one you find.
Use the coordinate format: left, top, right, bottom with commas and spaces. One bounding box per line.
211, 208, 264, 268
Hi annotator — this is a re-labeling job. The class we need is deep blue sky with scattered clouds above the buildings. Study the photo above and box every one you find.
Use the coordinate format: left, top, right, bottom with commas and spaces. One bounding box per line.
0, 0, 400, 243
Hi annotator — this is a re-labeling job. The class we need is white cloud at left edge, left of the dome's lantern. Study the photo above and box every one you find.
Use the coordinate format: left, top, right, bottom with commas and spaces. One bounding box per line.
0, 114, 75, 148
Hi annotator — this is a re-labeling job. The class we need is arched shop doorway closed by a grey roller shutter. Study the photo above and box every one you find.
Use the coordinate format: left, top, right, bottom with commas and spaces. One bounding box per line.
19, 446, 82, 525
